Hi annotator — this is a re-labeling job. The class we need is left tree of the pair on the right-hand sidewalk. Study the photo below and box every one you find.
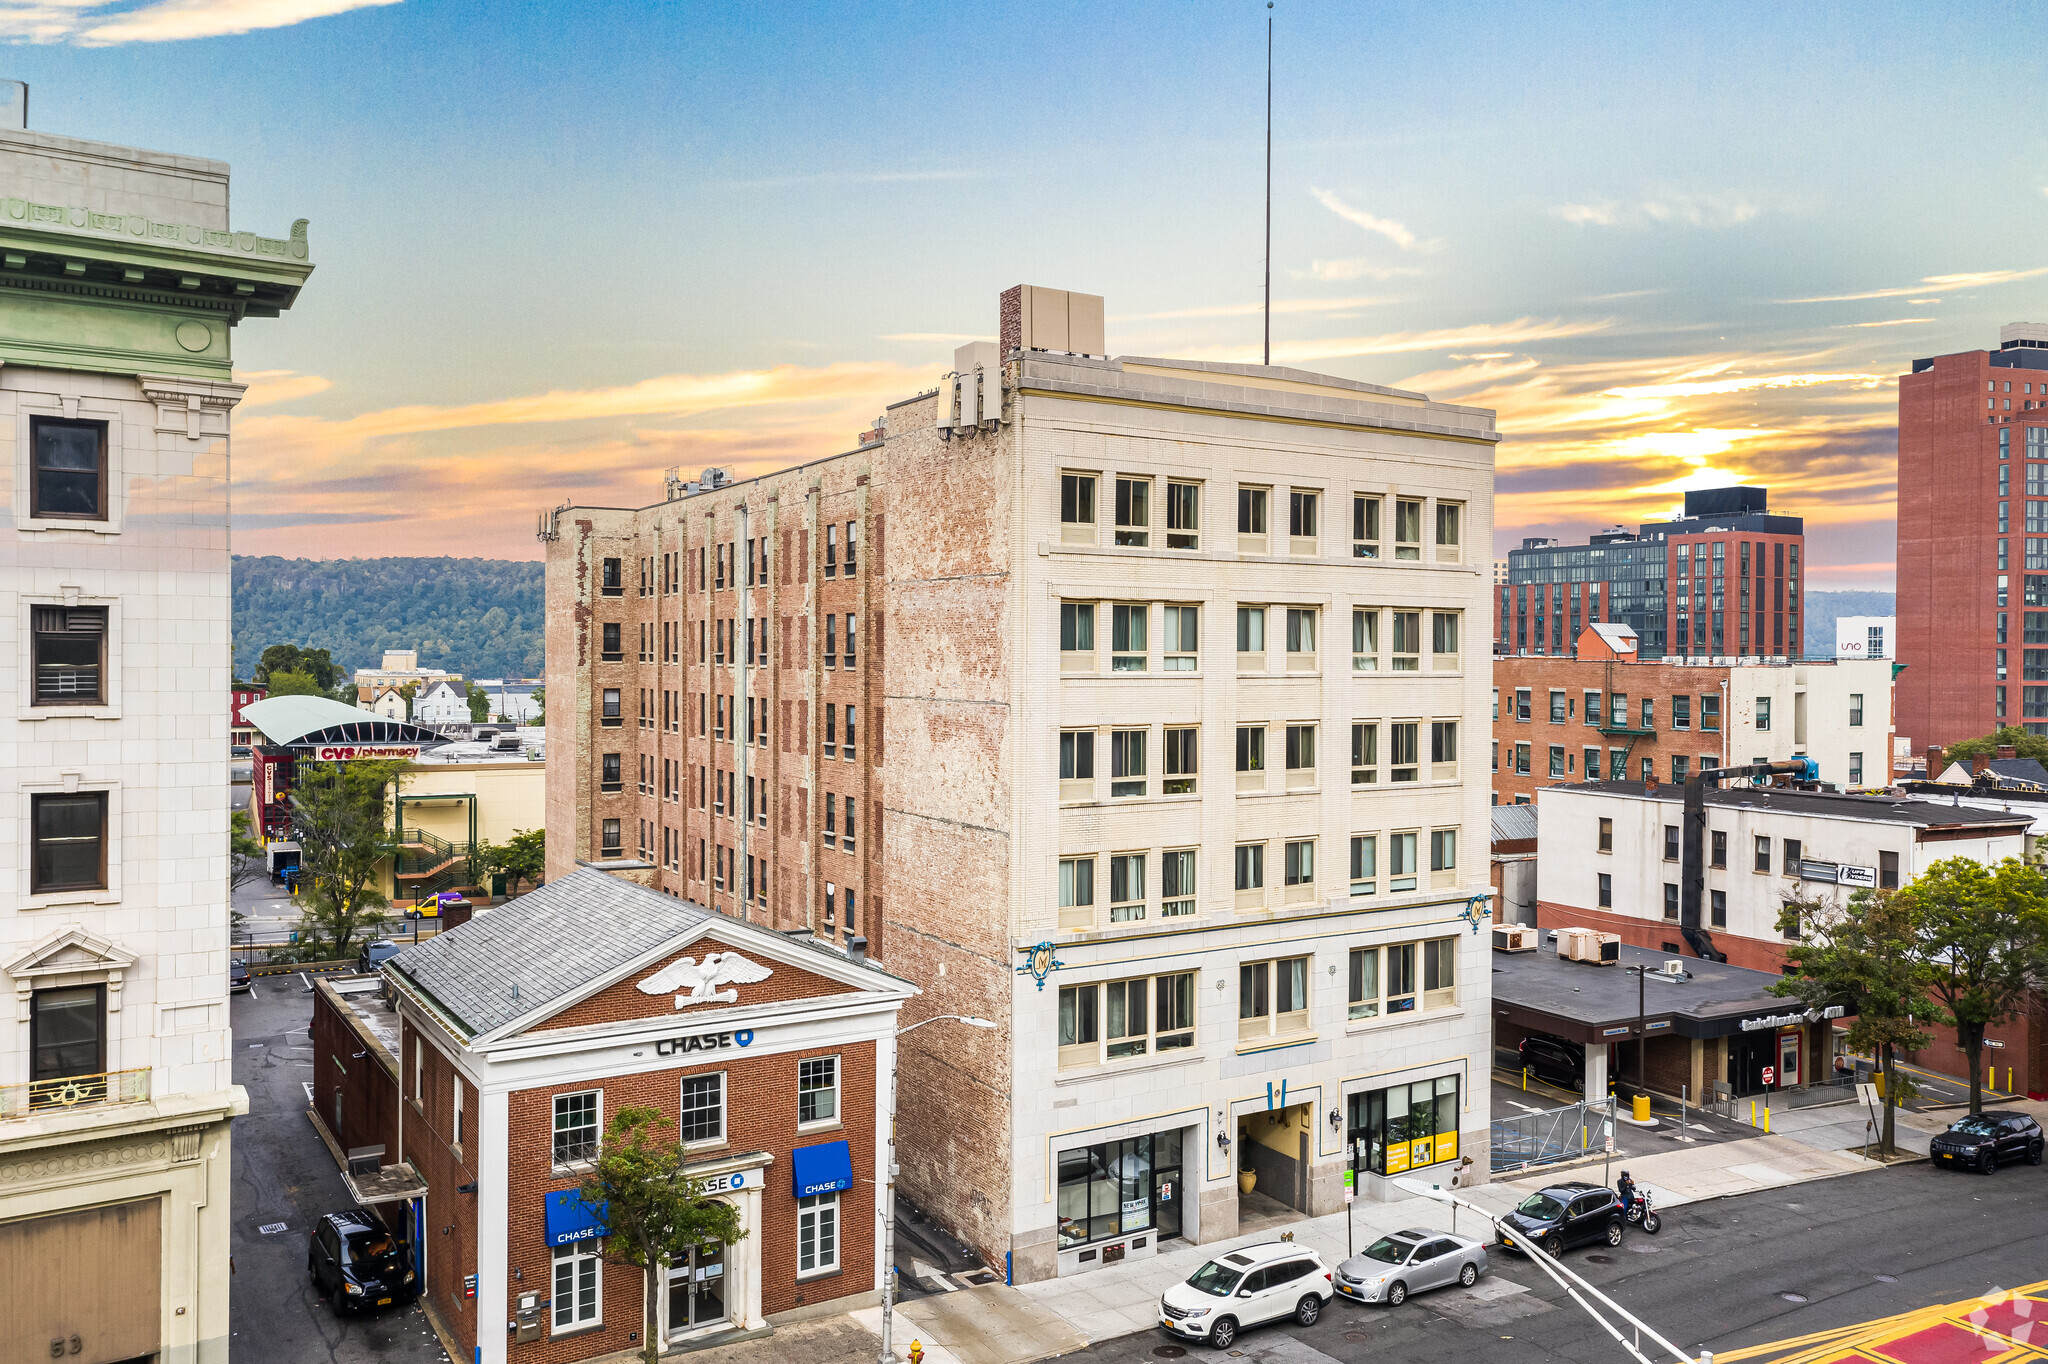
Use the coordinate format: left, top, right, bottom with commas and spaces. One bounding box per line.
1772, 891, 1933, 1155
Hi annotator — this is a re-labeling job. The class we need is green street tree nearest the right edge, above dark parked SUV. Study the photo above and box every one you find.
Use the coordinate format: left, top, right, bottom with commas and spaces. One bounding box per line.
1898, 858, 2048, 1112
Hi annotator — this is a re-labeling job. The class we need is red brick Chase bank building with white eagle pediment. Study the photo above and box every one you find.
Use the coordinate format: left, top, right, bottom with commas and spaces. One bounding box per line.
311, 870, 915, 1364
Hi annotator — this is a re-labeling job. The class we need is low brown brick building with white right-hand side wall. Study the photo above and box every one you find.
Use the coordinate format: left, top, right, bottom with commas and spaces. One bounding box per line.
1491, 625, 1892, 805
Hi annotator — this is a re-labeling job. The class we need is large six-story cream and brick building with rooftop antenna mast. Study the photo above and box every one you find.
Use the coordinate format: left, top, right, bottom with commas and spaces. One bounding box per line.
541, 289, 1497, 1282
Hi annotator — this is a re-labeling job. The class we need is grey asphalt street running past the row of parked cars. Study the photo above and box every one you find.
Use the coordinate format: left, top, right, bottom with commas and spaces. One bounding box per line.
1073, 1165, 2048, 1364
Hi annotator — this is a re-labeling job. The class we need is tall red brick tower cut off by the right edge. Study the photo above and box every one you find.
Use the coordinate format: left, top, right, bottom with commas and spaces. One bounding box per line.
1896, 322, 2048, 754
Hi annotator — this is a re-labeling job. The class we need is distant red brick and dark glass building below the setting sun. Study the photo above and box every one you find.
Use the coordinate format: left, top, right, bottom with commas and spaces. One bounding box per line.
1493, 487, 1806, 659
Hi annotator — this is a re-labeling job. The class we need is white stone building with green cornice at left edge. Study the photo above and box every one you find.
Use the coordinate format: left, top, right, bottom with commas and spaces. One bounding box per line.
0, 114, 311, 1364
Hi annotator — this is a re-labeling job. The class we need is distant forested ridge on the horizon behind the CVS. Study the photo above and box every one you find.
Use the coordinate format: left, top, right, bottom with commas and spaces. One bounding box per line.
233, 555, 545, 678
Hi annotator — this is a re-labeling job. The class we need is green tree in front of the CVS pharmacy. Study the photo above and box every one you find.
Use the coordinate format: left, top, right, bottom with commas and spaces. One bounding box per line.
291, 760, 406, 956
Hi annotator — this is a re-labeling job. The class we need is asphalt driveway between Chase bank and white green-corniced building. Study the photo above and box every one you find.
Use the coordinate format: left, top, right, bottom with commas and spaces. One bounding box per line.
231, 975, 449, 1364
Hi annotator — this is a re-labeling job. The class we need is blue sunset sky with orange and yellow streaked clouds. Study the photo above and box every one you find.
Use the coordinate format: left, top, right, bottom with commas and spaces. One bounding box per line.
0, 0, 2048, 590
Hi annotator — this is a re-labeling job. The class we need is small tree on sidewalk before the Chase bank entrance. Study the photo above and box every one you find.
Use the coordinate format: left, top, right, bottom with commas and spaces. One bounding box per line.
578, 1108, 745, 1364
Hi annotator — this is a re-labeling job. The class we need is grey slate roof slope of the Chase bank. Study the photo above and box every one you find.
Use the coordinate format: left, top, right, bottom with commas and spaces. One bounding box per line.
385, 866, 719, 1036
